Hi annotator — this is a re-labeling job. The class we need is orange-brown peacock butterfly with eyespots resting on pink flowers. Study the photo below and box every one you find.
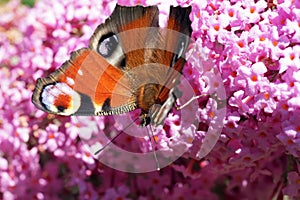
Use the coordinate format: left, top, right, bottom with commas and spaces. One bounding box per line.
32, 5, 192, 126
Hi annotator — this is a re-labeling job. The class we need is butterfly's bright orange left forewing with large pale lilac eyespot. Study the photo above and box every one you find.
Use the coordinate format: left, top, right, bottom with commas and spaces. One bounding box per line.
32, 48, 135, 115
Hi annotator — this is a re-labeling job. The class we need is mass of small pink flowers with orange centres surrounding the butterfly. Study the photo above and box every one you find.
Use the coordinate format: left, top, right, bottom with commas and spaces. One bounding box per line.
0, 0, 300, 200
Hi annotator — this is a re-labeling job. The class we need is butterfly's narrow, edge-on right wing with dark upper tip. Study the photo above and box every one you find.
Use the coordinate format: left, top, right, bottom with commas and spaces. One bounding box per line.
146, 7, 192, 126
